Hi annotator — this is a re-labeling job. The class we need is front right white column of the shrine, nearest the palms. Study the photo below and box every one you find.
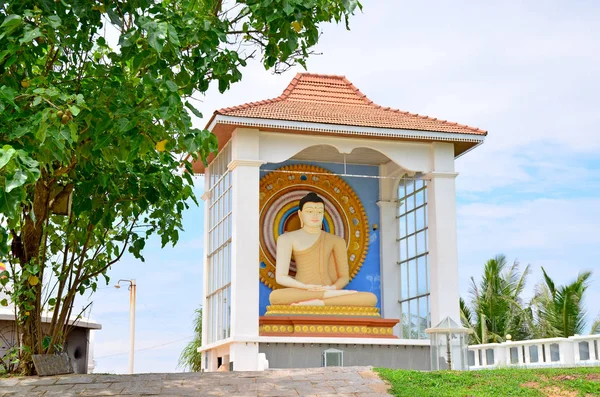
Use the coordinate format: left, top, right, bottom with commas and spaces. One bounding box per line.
427, 143, 460, 326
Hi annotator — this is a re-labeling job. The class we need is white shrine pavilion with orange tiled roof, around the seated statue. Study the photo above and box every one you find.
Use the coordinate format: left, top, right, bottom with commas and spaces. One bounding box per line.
194, 73, 487, 371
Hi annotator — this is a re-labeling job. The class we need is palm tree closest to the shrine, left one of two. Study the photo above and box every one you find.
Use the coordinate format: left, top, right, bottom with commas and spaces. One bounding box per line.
460, 255, 531, 343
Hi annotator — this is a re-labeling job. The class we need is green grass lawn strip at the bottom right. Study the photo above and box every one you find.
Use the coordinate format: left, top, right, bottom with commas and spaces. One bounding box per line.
375, 367, 600, 397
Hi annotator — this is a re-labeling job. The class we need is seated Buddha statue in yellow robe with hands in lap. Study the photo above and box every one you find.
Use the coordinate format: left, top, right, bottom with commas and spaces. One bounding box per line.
269, 193, 377, 307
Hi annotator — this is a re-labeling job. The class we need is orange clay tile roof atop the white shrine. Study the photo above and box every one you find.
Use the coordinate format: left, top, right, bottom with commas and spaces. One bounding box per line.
215, 73, 487, 135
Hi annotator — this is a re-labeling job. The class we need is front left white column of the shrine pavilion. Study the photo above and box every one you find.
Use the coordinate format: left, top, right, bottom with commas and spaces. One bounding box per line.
228, 129, 262, 371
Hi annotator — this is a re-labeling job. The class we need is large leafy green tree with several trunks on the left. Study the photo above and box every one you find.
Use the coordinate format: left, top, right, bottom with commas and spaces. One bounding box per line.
0, 0, 360, 374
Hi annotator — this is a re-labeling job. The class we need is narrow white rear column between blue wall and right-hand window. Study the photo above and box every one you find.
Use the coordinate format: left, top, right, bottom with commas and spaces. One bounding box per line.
377, 201, 400, 330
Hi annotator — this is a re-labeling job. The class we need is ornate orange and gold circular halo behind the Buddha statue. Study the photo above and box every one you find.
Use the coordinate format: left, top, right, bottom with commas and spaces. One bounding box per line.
260, 164, 369, 289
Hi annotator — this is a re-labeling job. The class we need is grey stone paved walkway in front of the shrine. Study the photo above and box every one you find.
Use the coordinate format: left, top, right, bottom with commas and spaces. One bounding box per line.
0, 367, 389, 397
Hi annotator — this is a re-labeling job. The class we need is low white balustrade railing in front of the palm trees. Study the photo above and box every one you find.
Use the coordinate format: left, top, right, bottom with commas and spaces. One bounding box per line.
467, 335, 600, 370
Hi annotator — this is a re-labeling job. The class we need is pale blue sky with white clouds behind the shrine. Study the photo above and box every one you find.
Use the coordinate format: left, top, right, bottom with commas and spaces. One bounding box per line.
86, 0, 600, 373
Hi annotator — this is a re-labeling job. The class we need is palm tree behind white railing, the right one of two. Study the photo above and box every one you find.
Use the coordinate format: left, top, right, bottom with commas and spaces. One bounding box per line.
531, 267, 597, 338
